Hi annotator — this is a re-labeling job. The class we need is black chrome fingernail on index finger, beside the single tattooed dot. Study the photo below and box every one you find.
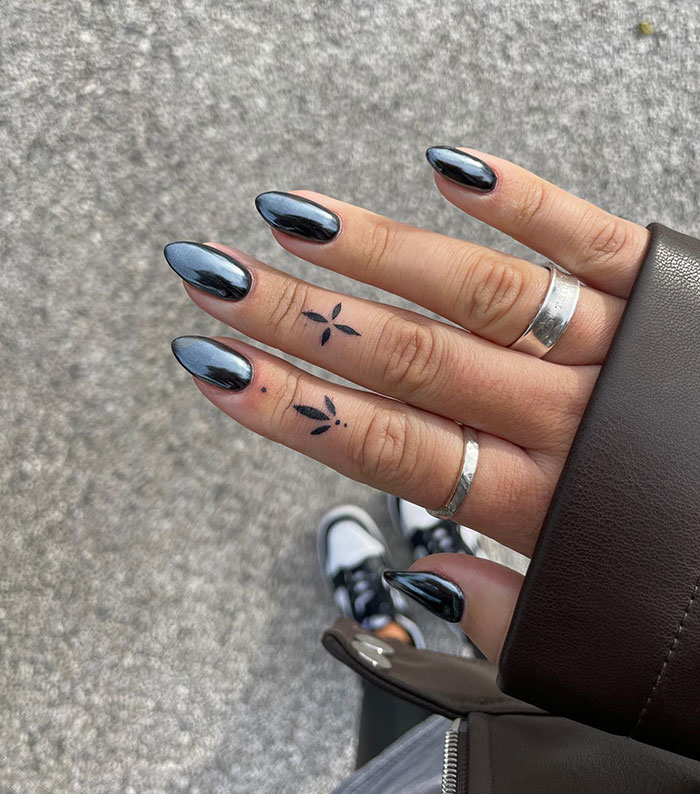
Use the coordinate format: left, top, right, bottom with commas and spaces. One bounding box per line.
171, 336, 253, 391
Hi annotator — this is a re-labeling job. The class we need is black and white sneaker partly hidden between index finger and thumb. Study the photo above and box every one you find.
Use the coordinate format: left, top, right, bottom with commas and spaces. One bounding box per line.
387, 494, 486, 560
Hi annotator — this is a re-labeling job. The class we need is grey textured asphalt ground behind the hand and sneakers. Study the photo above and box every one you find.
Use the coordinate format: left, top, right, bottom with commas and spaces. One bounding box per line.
0, 0, 700, 794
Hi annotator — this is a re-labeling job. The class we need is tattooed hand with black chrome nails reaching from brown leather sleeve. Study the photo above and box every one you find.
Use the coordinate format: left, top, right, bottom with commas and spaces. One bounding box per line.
166, 147, 648, 661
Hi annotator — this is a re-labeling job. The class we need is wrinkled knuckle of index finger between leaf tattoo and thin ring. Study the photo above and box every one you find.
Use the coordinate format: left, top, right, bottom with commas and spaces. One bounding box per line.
356, 410, 417, 484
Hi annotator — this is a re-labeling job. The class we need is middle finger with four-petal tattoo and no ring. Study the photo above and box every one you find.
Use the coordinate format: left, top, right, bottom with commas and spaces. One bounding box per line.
167, 243, 592, 451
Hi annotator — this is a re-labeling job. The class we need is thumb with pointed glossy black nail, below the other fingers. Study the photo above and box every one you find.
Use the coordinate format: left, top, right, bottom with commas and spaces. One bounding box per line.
384, 554, 523, 663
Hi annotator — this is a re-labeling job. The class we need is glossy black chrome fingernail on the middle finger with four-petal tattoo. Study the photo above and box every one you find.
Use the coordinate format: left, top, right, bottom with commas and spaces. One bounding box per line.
163, 242, 252, 301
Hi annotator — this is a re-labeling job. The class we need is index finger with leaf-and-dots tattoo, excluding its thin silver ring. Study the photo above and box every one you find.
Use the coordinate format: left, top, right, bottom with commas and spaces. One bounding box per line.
173, 337, 554, 553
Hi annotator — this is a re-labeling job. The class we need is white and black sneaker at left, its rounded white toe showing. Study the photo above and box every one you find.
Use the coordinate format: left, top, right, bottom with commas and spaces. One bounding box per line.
318, 505, 425, 648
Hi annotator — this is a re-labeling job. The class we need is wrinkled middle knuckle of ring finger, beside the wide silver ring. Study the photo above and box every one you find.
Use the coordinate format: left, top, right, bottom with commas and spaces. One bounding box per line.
464, 255, 525, 331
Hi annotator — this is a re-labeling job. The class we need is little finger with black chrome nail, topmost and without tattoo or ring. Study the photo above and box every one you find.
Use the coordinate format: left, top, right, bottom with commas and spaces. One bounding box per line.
427, 146, 649, 298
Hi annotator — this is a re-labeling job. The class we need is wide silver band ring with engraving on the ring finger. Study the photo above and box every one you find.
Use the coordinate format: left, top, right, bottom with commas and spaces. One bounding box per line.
510, 262, 581, 358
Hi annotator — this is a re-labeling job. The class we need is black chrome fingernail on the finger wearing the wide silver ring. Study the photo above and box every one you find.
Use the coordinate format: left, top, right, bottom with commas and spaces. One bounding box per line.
255, 190, 340, 243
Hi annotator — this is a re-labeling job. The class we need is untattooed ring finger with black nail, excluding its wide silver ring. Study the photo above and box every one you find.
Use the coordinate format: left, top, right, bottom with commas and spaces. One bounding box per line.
257, 191, 623, 364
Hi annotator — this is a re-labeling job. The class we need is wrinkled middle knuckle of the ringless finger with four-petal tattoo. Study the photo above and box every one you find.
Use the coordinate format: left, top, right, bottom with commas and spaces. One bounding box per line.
382, 317, 442, 396
